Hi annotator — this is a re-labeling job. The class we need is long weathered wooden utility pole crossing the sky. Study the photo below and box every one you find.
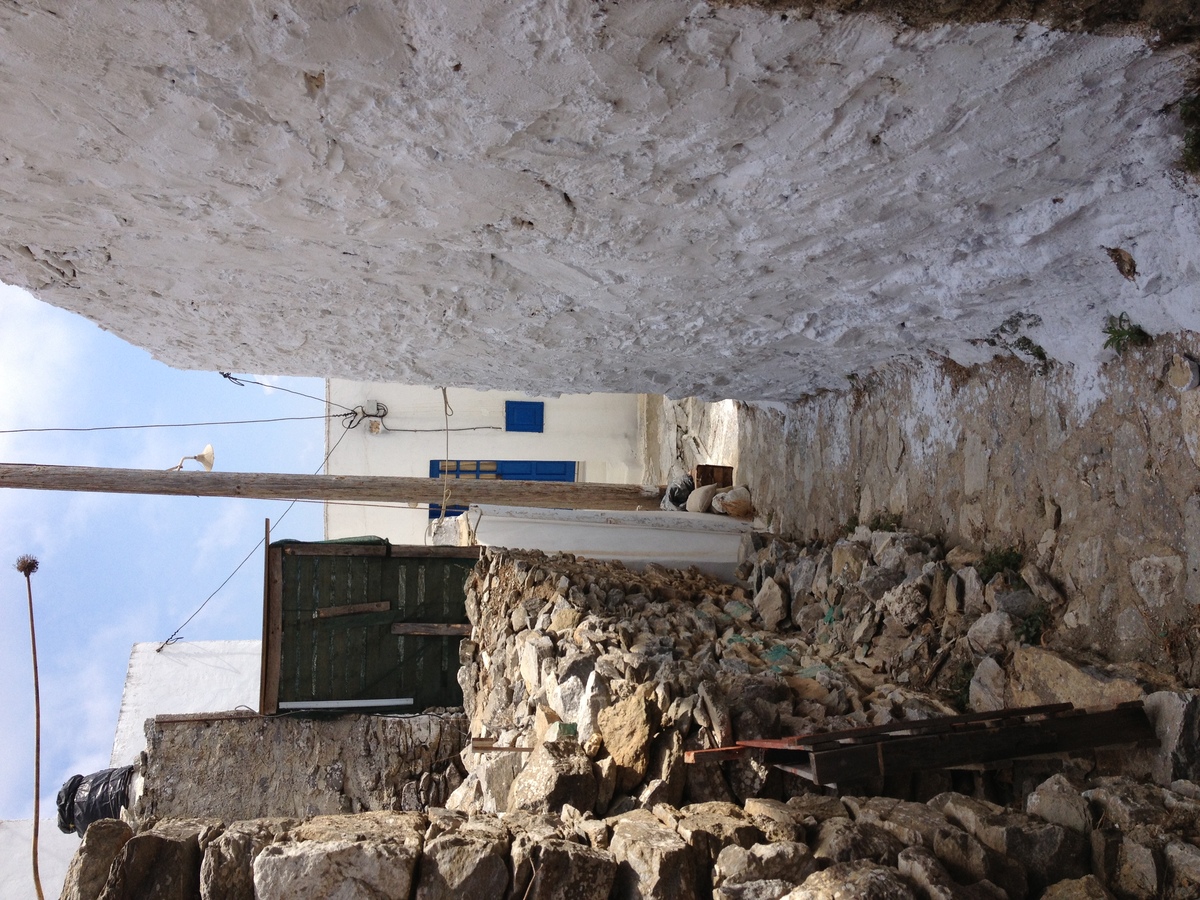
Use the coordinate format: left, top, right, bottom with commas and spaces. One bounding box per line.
0, 463, 661, 510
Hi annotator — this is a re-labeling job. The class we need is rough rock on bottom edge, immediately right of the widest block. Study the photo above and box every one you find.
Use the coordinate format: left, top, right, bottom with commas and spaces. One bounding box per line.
415, 828, 511, 900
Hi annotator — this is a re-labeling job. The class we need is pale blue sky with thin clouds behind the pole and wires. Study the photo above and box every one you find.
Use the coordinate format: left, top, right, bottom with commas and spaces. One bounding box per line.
0, 286, 324, 818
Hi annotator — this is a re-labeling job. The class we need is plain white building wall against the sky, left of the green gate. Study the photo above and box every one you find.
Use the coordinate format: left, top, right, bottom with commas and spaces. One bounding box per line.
109, 641, 262, 775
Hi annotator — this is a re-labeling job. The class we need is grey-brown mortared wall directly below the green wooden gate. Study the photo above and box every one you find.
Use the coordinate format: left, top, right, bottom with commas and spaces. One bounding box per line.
131, 713, 466, 823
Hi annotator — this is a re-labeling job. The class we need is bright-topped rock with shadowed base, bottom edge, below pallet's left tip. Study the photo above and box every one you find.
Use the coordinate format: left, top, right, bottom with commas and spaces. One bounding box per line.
608, 816, 702, 900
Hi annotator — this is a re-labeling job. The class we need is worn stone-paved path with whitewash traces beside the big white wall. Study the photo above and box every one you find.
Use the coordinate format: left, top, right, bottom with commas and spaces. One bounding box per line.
656, 340, 1200, 684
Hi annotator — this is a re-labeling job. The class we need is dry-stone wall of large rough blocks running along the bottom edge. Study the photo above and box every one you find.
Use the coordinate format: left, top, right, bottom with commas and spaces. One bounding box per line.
62, 775, 1200, 900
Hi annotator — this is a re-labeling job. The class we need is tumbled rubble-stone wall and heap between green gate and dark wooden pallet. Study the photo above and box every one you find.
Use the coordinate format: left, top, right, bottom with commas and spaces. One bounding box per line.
451, 542, 1200, 816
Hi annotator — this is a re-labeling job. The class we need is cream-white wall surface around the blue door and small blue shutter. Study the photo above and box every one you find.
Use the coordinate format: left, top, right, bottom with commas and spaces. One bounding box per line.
325, 378, 642, 546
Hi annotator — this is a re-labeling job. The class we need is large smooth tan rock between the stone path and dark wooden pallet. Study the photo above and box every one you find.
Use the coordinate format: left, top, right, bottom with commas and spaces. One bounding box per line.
1008, 647, 1144, 707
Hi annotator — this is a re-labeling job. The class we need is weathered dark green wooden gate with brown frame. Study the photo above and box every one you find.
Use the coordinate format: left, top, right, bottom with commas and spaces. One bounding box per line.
259, 539, 479, 714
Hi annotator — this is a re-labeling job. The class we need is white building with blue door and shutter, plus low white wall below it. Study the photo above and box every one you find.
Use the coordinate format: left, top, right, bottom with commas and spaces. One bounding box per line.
325, 379, 749, 577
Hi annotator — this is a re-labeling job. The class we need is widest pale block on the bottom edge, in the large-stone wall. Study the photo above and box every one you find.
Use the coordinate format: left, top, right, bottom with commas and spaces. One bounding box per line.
254, 840, 419, 900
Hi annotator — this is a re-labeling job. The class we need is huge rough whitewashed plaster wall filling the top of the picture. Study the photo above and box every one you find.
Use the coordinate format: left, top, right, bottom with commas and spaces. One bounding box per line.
0, 0, 1200, 398
